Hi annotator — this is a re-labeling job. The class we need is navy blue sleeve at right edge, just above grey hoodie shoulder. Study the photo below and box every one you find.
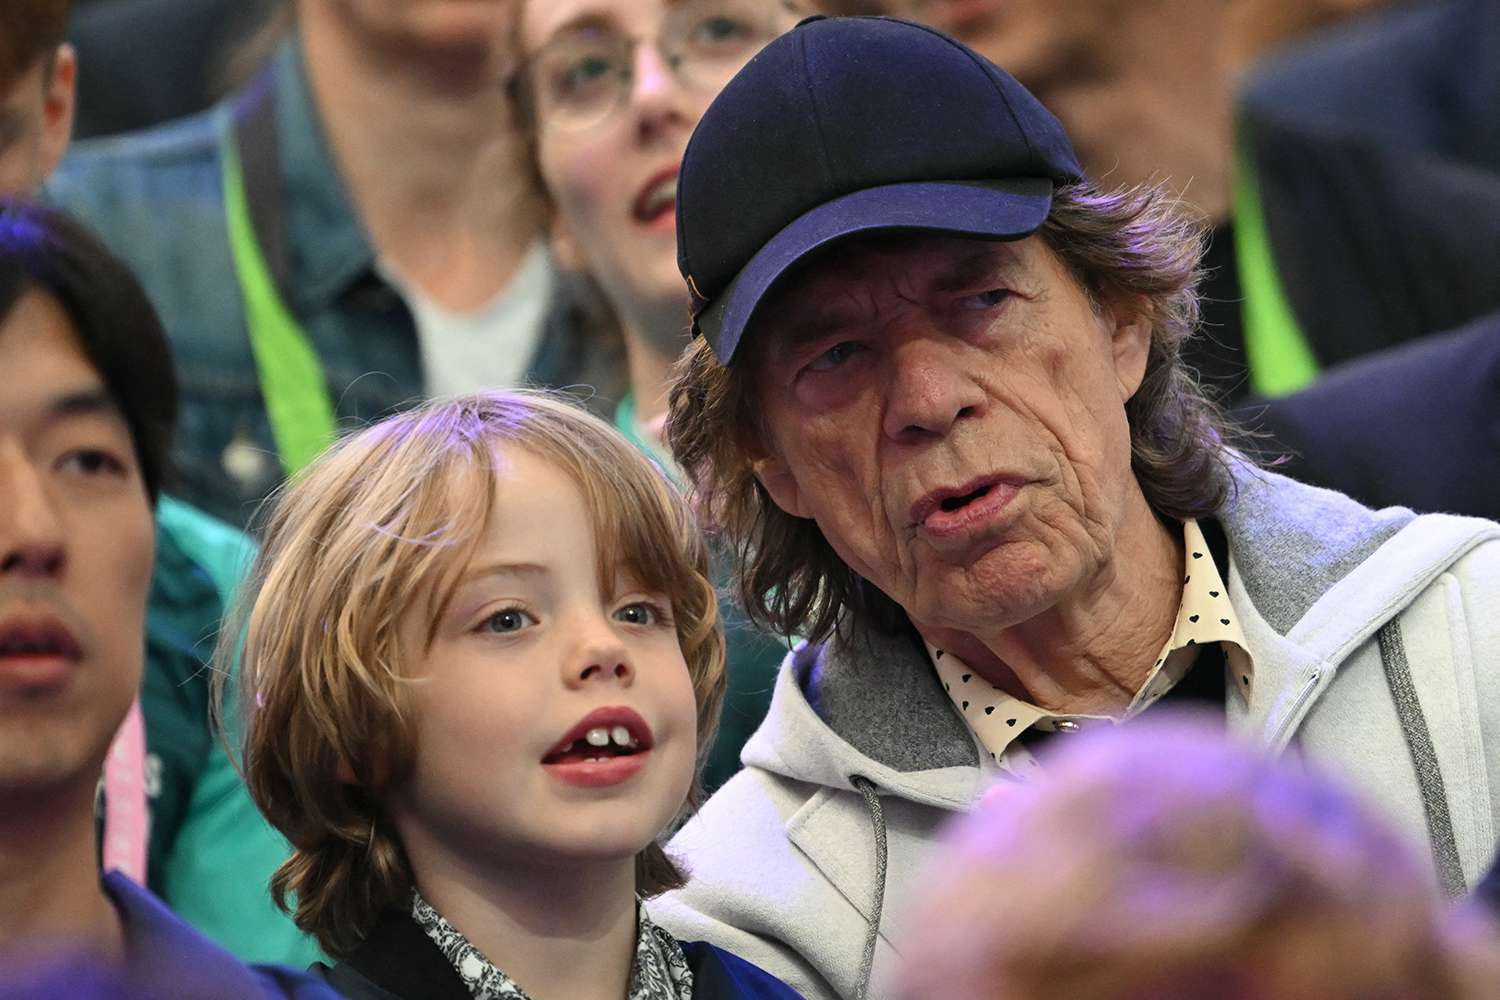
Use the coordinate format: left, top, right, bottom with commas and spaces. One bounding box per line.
1242, 313, 1500, 520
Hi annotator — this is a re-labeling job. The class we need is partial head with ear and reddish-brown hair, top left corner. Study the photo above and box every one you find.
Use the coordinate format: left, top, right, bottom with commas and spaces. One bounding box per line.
0, 0, 78, 190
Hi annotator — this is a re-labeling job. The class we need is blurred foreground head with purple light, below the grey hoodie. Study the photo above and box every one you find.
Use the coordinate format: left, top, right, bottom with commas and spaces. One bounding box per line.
897, 718, 1500, 1000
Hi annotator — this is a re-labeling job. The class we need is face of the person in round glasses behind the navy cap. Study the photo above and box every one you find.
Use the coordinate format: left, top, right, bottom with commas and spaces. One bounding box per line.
521, 0, 795, 340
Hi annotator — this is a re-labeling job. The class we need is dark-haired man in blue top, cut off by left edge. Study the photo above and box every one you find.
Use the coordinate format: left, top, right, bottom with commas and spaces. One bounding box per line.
0, 201, 332, 1000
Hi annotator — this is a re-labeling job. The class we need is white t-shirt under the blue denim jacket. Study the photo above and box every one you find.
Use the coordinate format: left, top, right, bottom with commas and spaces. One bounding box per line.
377, 240, 552, 396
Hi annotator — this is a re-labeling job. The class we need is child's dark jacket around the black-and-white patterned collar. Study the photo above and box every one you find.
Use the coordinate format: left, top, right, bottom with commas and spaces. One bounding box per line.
317, 910, 798, 1000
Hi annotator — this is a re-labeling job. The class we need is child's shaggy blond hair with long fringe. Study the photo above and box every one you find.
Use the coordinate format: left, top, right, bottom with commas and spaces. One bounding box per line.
221, 393, 725, 955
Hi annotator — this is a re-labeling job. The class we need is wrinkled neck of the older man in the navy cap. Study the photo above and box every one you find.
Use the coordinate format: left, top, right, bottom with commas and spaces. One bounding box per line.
920, 498, 1184, 715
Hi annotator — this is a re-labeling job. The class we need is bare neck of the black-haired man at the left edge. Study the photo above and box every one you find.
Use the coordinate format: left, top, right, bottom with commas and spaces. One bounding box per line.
0, 783, 125, 964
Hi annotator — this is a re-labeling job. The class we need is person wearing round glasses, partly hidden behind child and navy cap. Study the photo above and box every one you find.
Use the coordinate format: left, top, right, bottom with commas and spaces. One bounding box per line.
512, 0, 804, 792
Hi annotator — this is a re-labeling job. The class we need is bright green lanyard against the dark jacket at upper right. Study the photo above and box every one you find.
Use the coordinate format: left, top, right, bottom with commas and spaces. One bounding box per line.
1235, 139, 1319, 396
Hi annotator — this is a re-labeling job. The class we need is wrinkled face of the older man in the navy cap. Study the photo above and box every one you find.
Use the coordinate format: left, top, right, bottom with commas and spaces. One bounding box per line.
746, 237, 1151, 634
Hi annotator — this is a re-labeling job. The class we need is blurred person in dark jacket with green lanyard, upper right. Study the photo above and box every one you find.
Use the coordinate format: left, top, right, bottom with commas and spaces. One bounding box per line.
900, 0, 1500, 402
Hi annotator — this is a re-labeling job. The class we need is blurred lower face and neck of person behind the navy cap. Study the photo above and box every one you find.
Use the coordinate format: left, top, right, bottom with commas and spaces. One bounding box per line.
891, 0, 1386, 219
